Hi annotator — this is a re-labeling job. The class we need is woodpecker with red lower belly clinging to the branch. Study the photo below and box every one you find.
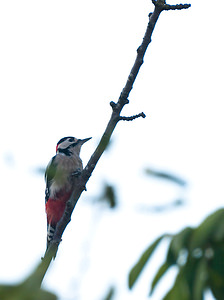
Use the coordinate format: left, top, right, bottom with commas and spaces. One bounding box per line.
45, 136, 91, 248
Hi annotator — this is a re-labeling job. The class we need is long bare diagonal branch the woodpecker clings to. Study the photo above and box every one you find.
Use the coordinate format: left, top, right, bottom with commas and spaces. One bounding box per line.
37, 0, 190, 283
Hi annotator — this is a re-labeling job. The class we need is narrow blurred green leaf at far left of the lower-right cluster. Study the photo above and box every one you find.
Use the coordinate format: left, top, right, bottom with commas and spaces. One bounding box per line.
128, 234, 170, 289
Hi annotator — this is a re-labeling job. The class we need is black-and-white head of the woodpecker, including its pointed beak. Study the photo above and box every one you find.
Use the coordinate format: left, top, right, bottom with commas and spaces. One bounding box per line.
56, 136, 91, 156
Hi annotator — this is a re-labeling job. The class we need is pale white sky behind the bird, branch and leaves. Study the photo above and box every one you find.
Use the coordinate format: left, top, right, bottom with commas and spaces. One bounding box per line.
0, 0, 224, 300
